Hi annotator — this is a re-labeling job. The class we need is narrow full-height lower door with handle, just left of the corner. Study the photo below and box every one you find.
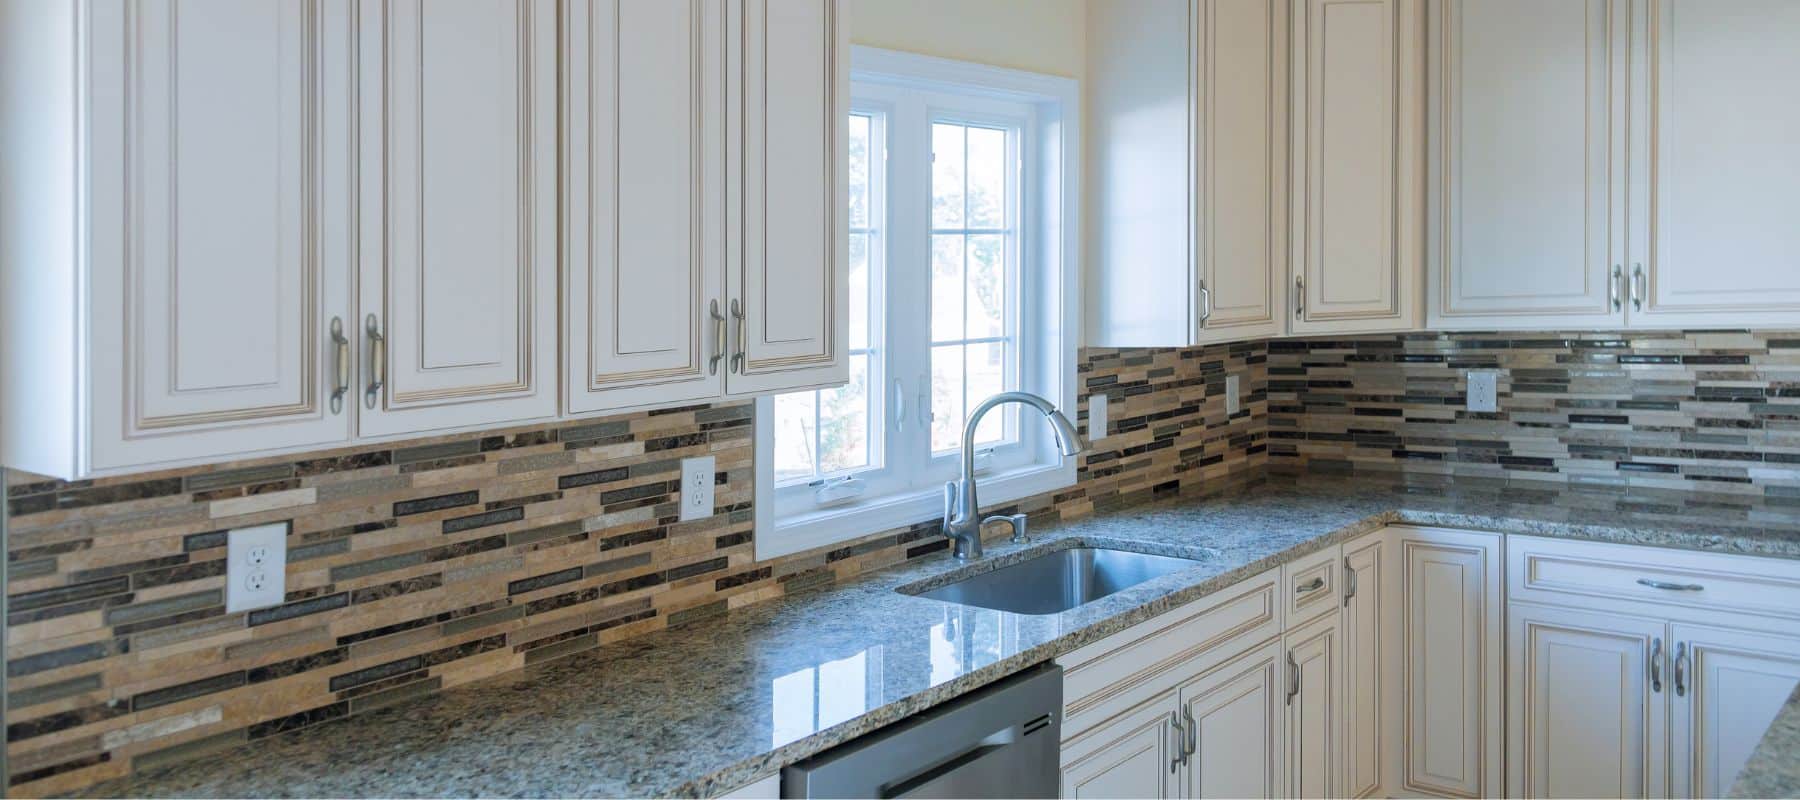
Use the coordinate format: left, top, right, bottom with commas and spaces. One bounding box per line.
1337, 533, 1388, 798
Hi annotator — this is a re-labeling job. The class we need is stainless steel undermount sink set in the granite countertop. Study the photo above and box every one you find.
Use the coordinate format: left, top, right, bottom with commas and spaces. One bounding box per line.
918, 548, 1201, 614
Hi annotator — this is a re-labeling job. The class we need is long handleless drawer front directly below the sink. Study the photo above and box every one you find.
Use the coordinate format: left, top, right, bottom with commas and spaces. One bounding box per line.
1057, 569, 1282, 741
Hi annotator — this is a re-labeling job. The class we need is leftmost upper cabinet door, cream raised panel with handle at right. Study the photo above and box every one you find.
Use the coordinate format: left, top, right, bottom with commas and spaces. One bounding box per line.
86, 0, 355, 470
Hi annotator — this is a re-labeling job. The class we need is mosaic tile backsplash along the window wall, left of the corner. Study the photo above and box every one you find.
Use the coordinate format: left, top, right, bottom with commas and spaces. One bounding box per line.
5, 342, 1269, 796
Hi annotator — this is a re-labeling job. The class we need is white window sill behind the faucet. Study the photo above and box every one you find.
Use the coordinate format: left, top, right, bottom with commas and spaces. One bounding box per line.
756, 458, 1075, 560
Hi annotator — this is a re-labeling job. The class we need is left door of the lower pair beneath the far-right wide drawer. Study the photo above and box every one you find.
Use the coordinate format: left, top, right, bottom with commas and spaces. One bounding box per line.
1507, 604, 1672, 798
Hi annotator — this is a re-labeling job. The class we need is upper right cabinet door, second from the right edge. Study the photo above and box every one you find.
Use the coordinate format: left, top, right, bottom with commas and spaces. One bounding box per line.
1426, 0, 1631, 330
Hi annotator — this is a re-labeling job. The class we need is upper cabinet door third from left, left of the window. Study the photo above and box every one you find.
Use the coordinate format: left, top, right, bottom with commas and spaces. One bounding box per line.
562, 0, 727, 413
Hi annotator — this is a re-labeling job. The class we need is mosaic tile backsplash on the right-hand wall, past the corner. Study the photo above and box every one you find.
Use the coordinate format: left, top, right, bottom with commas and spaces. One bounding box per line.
1269, 332, 1800, 503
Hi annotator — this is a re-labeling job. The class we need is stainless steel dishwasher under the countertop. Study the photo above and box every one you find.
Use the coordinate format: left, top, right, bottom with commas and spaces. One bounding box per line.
781, 665, 1062, 798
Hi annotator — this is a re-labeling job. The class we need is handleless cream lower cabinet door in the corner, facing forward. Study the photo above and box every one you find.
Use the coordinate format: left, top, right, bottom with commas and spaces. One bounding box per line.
1388, 528, 1505, 796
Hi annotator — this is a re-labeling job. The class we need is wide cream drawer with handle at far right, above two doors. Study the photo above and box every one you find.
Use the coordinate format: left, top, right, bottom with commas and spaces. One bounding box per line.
1507, 537, 1800, 622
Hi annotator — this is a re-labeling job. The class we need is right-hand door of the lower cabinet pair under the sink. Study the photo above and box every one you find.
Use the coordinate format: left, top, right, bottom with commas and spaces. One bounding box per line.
1181, 641, 1287, 798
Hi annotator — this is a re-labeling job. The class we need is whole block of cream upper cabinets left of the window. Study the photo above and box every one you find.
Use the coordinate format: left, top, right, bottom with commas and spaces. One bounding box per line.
0, 0, 850, 479
